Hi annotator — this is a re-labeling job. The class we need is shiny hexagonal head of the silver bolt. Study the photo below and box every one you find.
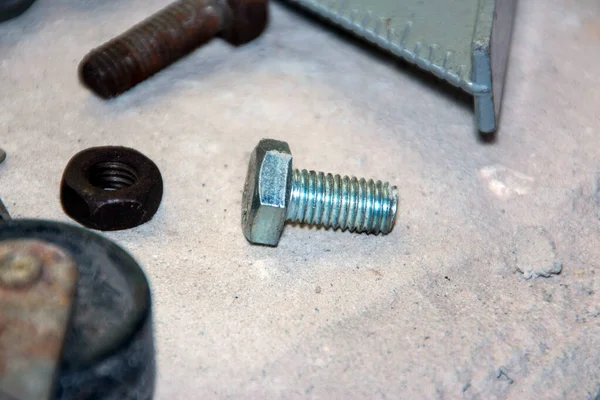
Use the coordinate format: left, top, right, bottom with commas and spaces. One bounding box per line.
242, 139, 292, 246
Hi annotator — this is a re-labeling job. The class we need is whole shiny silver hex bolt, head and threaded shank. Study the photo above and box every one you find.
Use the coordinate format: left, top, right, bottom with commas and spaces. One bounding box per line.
242, 139, 398, 246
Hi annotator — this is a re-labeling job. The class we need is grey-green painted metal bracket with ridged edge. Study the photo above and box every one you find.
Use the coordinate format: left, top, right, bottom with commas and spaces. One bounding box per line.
286, 0, 517, 133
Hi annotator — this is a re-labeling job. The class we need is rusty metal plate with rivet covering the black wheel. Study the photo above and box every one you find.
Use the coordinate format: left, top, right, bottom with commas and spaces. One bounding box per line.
0, 239, 77, 400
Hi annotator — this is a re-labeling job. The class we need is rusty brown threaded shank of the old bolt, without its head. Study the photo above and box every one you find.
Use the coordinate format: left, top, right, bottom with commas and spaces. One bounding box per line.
79, 0, 225, 98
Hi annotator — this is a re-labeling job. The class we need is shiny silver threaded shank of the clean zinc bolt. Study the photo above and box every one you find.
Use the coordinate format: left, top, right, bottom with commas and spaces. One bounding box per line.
286, 169, 398, 234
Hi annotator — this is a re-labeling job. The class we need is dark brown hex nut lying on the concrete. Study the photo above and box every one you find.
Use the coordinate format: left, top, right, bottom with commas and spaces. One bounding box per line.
60, 146, 163, 231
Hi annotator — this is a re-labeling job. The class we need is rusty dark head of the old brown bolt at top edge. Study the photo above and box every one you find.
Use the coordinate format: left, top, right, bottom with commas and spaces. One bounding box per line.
220, 0, 269, 46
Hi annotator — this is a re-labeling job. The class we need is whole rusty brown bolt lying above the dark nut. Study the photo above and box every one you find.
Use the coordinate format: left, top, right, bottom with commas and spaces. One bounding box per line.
79, 0, 268, 98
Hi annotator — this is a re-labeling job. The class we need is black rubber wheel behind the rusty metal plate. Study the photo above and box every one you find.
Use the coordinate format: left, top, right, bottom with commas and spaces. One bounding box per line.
0, 220, 156, 400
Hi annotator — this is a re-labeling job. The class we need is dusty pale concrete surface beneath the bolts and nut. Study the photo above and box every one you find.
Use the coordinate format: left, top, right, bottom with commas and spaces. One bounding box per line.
0, 0, 600, 399
